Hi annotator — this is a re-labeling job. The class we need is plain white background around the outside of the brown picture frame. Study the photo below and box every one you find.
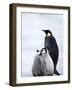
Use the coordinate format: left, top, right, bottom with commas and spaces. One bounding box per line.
0, 0, 72, 90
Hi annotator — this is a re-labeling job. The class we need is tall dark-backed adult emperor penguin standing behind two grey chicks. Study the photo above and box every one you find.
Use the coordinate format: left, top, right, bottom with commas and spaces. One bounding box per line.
42, 30, 60, 75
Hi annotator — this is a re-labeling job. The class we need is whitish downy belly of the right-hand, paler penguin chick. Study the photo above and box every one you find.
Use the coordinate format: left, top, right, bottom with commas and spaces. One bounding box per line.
45, 55, 54, 74
